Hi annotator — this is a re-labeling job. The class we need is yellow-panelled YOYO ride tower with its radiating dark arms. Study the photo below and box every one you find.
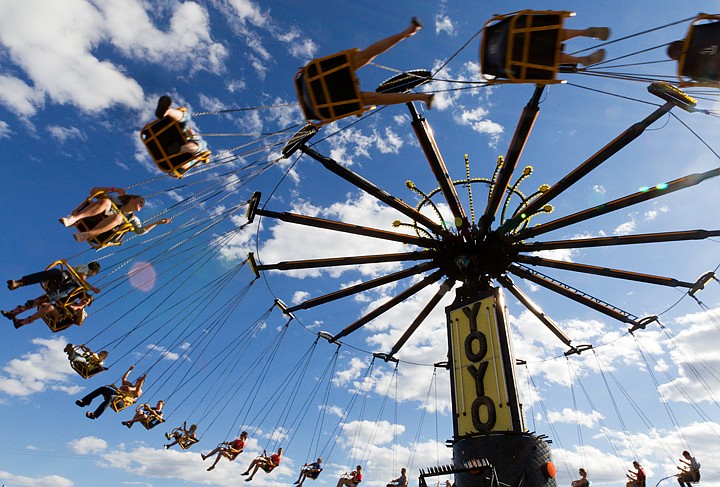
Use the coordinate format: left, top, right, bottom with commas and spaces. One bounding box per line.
255, 54, 720, 487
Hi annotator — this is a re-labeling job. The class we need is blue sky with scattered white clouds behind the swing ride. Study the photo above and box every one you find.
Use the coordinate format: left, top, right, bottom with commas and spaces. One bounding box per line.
0, 0, 720, 487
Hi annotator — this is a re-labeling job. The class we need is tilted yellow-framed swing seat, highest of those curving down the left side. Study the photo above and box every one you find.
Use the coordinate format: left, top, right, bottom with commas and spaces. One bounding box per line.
140, 114, 211, 178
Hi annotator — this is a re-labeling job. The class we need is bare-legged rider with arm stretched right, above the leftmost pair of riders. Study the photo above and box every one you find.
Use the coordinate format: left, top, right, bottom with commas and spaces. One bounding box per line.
60, 188, 171, 242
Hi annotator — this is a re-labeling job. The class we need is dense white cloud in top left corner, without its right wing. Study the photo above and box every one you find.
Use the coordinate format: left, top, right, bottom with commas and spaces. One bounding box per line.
0, 0, 142, 115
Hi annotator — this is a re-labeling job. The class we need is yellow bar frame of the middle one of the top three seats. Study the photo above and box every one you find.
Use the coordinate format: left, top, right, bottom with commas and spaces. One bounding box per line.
480, 10, 575, 85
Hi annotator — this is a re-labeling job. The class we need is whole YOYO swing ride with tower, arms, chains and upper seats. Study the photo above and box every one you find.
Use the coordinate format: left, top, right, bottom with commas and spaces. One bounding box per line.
7, 7, 720, 487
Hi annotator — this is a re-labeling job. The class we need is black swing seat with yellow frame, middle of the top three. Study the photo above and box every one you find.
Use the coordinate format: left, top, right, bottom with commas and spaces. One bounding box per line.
480, 10, 575, 85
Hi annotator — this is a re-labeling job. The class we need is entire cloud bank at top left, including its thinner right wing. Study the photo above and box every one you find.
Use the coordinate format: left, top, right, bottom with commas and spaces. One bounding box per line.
0, 0, 227, 116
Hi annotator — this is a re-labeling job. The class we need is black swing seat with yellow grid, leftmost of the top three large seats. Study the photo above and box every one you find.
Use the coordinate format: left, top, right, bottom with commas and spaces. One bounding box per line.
295, 49, 372, 127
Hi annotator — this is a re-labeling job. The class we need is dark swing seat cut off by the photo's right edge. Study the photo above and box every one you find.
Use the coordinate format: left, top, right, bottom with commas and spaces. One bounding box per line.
678, 14, 720, 87
